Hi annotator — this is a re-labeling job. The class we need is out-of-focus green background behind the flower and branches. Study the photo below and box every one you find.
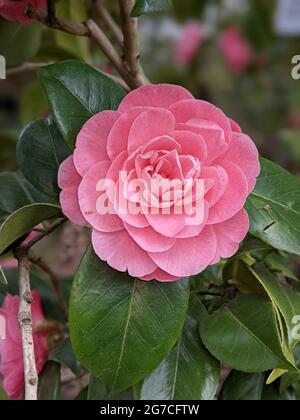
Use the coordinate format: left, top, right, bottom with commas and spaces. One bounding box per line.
0, 0, 300, 175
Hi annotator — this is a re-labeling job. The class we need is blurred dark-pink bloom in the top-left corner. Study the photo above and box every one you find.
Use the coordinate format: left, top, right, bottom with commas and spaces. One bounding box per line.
0, 0, 47, 25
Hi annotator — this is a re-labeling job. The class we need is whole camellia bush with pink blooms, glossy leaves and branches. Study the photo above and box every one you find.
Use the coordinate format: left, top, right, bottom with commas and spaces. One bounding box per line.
0, 0, 300, 400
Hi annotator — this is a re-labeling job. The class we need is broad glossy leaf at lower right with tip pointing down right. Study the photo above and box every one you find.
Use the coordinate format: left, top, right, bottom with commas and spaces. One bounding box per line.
200, 296, 292, 373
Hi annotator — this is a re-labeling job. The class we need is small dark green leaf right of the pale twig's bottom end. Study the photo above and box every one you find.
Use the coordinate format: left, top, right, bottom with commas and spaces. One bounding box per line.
38, 362, 61, 401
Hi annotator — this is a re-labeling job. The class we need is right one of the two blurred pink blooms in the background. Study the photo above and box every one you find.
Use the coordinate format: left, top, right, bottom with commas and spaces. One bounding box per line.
219, 26, 253, 72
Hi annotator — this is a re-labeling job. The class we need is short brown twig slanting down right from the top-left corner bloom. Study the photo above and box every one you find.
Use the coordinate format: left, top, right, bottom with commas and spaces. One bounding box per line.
25, 4, 90, 36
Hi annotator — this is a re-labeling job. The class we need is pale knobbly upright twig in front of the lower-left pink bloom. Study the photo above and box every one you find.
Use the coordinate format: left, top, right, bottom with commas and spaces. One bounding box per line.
15, 248, 38, 401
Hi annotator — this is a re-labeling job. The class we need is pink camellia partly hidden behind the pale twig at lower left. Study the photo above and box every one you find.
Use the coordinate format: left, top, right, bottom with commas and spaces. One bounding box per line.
0, 291, 49, 400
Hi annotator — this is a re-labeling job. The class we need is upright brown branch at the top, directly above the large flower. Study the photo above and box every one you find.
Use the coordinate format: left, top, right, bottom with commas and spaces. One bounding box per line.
119, 0, 148, 87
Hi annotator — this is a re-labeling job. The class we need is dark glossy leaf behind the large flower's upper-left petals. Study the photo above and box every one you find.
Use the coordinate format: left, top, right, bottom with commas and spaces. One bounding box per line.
39, 60, 125, 148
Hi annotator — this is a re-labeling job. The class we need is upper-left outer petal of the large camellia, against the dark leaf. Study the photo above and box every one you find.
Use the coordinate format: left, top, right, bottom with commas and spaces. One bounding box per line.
73, 111, 121, 176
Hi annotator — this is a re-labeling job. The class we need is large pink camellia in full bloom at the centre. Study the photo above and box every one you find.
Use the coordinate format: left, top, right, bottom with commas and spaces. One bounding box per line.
59, 85, 260, 281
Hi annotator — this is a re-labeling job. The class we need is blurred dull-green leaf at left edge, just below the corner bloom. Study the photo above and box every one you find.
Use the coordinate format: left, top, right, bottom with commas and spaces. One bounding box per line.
0, 18, 43, 67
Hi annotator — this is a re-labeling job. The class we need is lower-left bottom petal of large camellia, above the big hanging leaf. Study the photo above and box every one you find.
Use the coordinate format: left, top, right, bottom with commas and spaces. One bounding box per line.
92, 230, 157, 277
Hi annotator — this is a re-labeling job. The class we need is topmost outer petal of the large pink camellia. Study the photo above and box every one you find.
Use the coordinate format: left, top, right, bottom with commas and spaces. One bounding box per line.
119, 84, 194, 112
